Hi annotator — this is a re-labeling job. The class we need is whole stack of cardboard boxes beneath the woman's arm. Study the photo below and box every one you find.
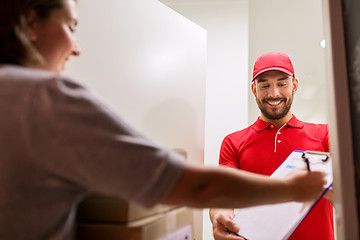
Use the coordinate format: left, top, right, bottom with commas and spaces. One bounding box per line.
76, 149, 194, 240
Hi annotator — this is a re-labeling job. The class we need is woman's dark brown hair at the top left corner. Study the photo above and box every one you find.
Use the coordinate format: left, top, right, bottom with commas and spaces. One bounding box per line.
0, 0, 73, 66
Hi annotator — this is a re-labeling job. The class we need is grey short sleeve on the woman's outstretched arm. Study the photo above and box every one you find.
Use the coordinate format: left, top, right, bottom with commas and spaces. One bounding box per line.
24, 77, 184, 206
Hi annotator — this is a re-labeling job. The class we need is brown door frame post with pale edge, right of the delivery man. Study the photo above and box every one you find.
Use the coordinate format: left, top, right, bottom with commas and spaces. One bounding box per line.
323, 0, 359, 237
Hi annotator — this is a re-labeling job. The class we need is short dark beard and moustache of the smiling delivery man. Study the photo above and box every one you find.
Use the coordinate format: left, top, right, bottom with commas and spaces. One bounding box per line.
256, 94, 294, 120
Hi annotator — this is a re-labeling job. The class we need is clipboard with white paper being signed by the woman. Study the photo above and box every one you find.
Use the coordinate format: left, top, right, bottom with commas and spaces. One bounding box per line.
233, 150, 333, 240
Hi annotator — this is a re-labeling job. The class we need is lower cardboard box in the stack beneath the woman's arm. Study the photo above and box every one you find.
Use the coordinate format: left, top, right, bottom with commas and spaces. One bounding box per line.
76, 207, 194, 240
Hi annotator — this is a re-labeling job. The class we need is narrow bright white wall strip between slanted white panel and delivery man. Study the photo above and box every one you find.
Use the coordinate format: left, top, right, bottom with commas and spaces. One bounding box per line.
161, 0, 248, 240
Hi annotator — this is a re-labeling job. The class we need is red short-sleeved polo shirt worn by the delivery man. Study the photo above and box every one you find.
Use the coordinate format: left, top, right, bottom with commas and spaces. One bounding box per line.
219, 115, 334, 240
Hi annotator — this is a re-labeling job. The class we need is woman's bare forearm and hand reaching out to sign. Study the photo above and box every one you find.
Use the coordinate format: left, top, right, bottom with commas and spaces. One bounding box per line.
163, 163, 325, 208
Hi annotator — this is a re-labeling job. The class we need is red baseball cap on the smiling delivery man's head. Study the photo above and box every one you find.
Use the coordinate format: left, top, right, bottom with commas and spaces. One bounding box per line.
252, 52, 295, 81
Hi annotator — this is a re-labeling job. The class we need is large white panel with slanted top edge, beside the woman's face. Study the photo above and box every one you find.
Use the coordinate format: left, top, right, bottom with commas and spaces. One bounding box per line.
66, 0, 207, 238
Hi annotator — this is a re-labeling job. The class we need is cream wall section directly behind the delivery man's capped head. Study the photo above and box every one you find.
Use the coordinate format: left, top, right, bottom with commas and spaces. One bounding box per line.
249, 0, 328, 123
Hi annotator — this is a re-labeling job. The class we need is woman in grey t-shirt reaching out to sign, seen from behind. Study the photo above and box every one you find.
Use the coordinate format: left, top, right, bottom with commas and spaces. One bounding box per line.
0, 0, 324, 239
